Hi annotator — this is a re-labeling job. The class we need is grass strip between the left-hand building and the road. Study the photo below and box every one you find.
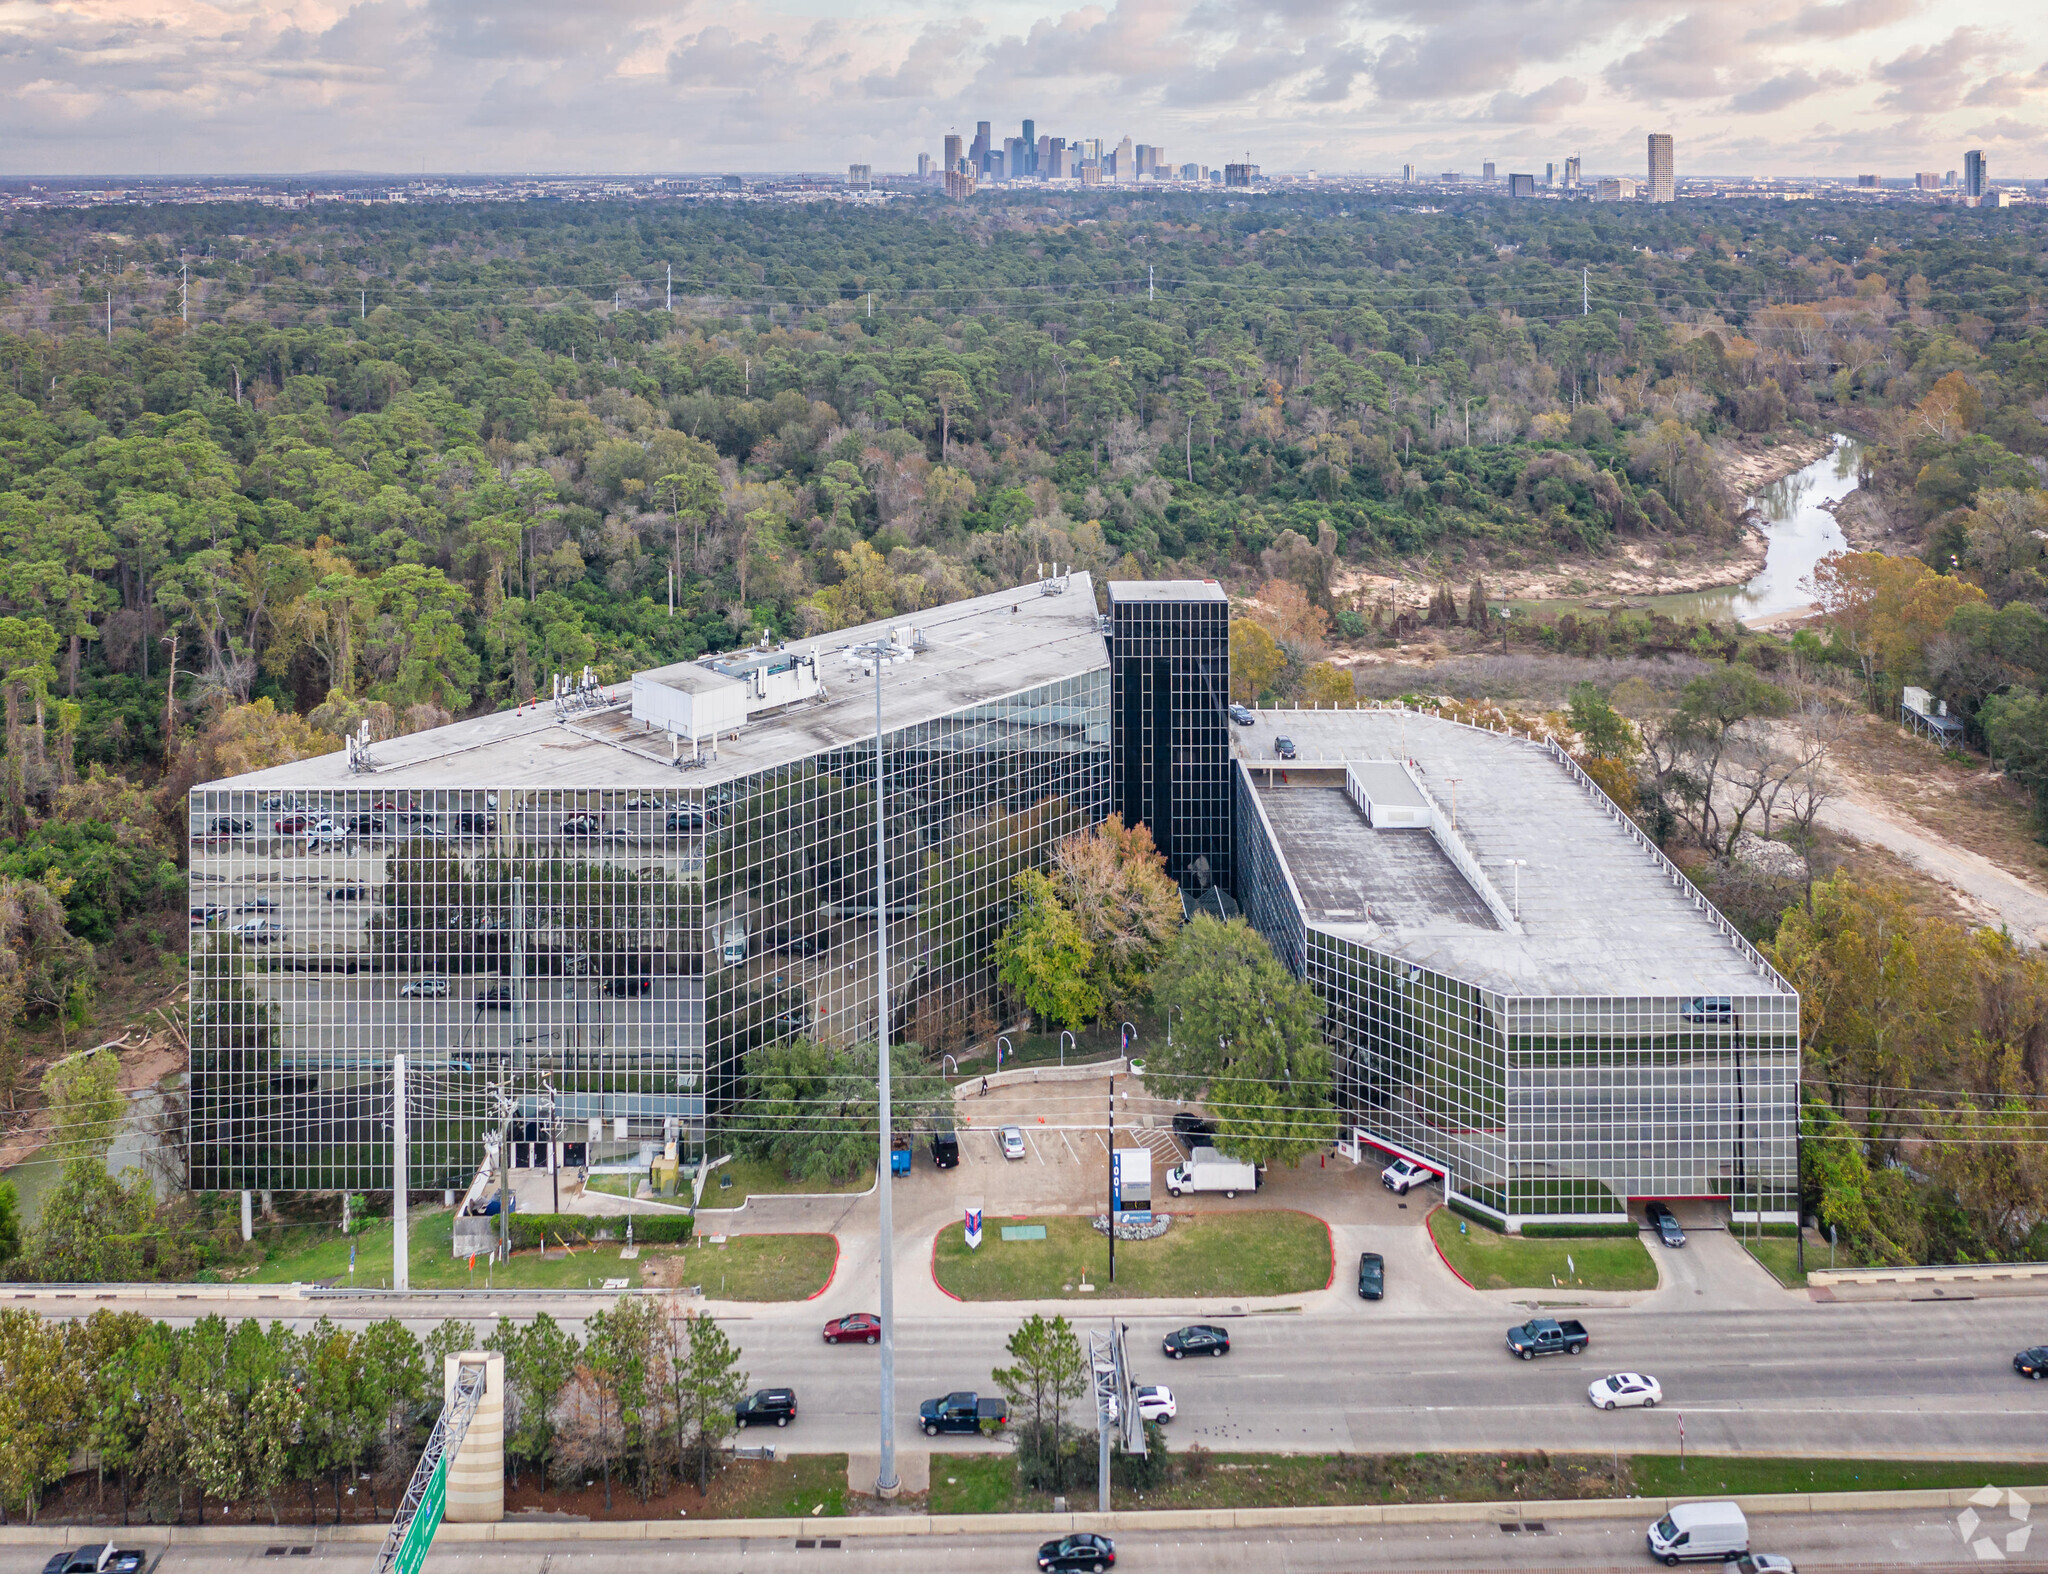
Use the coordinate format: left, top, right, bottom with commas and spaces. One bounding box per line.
242, 1210, 840, 1300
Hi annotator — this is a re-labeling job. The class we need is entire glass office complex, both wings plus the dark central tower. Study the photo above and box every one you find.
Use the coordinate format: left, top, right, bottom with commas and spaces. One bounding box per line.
190, 573, 1798, 1220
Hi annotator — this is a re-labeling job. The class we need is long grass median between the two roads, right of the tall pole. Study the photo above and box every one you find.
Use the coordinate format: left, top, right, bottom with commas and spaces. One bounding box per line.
930, 1429, 2048, 1523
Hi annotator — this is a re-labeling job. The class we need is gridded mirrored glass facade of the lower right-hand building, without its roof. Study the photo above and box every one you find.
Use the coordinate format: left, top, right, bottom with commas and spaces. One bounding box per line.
1237, 774, 1798, 1226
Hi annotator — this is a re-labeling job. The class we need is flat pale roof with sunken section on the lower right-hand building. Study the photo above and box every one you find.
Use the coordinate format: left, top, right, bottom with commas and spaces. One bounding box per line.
1233, 710, 1790, 997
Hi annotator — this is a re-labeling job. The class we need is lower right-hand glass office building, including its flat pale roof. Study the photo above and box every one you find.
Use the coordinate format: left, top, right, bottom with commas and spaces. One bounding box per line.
1237, 710, 1798, 1228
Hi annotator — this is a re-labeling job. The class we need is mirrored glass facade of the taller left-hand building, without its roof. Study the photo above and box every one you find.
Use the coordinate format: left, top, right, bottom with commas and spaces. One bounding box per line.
190, 667, 1110, 1189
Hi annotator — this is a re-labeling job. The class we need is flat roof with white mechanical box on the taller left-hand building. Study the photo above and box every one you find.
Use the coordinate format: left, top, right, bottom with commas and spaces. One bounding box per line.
203, 573, 1108, 790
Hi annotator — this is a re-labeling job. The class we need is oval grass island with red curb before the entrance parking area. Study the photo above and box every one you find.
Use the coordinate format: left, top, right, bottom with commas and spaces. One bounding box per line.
938, 1210, 1331, 1300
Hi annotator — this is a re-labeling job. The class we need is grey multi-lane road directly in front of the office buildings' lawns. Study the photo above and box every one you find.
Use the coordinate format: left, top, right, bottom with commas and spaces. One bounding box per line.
16, 1287, 2048, 1461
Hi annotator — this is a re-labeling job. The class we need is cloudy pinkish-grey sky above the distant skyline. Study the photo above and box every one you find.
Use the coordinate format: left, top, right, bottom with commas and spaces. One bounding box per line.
0, 0, 2048, 178
